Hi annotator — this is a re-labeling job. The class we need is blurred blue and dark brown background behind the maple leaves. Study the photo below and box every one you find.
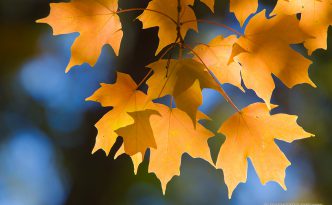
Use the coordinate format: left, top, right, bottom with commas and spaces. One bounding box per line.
0, 0, 332, 205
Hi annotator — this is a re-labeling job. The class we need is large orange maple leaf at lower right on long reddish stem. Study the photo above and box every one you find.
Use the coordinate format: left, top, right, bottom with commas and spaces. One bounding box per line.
217, 103, 313, 198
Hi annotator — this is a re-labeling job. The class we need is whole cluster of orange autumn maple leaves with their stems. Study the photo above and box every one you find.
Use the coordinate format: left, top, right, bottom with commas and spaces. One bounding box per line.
38, 0, 332, 199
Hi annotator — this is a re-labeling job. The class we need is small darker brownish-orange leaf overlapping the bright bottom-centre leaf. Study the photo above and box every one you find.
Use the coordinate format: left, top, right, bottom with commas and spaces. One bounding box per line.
115, 110, 158, 155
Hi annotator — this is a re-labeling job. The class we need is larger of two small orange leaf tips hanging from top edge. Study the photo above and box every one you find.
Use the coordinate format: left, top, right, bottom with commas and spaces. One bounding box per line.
230, 0, 258, 26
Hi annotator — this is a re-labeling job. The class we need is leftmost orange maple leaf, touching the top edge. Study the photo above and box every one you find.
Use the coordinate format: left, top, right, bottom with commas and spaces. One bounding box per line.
37, 0, 123, 72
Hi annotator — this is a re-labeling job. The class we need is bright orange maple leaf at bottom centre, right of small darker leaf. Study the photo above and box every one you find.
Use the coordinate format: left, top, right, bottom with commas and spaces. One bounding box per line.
149, 104, 214, 193
